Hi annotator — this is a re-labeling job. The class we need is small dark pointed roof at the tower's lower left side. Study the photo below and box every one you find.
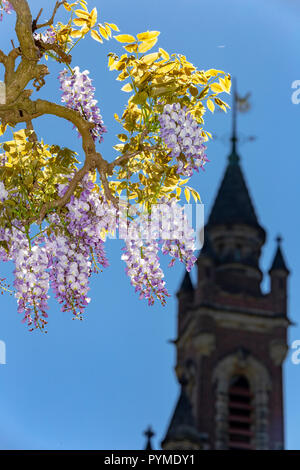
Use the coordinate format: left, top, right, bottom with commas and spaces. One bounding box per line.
163, 378, 201, 442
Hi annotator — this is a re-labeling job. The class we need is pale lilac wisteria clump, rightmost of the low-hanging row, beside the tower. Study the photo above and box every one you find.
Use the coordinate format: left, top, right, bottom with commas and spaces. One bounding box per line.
122, 198, 197, 305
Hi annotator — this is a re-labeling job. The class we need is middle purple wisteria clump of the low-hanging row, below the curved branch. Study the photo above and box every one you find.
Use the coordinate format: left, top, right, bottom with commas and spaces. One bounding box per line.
42, 175, 116, 316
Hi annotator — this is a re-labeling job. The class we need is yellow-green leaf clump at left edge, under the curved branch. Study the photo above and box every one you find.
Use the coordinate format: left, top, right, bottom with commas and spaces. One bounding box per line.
0, 129, 79, 225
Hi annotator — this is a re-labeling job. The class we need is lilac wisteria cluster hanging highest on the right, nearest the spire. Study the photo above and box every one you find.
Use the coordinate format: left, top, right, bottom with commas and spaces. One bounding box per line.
158, 103, 208, 176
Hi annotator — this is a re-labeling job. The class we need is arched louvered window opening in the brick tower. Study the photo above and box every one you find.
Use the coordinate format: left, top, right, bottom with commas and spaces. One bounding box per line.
228, 375, 253, 450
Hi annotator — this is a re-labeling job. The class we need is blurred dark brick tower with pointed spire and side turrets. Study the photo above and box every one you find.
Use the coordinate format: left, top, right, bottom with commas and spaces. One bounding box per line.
161, 88, 290, 450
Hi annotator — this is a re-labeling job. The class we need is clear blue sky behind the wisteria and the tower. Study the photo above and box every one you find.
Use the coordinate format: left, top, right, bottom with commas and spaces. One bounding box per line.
0, 0, 300, 449
